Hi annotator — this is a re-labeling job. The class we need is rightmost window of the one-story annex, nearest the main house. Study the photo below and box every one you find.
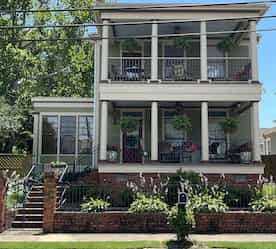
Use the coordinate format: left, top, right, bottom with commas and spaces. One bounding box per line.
78, 116, 93, 154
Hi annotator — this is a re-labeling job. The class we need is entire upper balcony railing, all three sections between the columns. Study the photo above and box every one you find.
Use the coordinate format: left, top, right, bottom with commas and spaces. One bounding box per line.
108, 57, 251, 81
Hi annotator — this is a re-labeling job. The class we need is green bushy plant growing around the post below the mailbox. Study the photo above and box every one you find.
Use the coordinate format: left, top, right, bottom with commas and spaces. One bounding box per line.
168, 205, 194, 241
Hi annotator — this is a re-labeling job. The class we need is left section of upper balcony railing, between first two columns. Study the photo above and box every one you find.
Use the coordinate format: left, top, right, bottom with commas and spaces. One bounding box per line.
108, 57, 151, 81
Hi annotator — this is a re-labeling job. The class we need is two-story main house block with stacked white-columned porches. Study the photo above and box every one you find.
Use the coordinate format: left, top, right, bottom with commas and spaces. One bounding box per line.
31, 4, 268, 186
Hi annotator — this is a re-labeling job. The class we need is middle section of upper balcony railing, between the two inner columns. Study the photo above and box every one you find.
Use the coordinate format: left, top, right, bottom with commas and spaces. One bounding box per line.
158, 57, 200, 81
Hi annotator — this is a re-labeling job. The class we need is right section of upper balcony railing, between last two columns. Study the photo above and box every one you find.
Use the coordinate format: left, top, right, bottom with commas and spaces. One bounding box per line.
208, 57, 251, 81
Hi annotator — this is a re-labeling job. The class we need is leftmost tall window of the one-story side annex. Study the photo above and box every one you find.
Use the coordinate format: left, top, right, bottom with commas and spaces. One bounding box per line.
42, 116, 58, 154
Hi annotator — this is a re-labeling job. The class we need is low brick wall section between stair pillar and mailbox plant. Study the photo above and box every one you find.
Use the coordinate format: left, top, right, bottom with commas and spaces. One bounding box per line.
53, 212, 172, 233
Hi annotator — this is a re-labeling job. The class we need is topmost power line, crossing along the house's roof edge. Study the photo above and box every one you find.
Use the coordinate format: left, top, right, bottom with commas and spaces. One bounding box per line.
0, 0, 276, 13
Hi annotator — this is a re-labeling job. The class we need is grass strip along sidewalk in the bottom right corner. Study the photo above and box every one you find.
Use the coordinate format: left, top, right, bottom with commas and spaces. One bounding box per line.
206, 242, 276, 249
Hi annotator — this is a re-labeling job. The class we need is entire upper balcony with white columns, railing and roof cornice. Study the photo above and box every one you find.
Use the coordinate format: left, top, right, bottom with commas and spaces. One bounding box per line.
97, 3, 265, 83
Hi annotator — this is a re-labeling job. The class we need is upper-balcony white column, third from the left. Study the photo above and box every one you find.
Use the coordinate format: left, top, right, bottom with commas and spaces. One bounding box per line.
200, 21, 208, 81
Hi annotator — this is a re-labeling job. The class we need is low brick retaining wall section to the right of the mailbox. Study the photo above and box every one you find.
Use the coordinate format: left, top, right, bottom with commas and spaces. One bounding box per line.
195, 212, 276, 233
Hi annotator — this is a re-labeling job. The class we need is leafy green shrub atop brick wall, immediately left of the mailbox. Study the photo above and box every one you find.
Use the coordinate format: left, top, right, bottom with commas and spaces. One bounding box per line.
129, 194, 168, 213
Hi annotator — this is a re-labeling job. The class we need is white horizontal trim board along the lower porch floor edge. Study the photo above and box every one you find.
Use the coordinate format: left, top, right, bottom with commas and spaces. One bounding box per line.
98, 163, 264, 175
